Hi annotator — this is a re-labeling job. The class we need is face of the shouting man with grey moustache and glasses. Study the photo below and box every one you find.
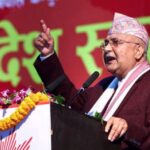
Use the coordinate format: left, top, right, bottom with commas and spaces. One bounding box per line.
103, 34, 140, 78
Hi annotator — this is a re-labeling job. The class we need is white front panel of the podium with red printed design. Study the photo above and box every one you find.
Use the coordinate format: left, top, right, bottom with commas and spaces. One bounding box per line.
0, 104, 51, 150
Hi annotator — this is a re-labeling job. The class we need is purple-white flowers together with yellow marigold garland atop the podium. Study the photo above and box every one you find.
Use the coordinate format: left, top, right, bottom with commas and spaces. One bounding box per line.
0, 89, 52, 131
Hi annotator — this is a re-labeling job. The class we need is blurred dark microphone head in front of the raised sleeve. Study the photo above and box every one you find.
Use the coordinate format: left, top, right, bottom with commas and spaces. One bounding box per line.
45, 74, 65, 93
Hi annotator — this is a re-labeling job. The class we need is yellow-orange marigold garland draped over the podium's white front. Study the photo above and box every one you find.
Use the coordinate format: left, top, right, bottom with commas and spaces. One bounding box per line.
0, 92, 50, 131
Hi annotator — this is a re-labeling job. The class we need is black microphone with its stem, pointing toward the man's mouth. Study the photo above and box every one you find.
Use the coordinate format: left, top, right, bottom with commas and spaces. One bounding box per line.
66, 71, 99, 107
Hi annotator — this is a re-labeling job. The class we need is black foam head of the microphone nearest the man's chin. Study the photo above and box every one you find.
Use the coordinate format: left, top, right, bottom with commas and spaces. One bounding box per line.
82, 71, 99, 89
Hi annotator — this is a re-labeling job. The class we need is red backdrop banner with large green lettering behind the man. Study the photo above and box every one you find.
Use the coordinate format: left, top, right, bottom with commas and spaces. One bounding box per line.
0, 0, 150, 90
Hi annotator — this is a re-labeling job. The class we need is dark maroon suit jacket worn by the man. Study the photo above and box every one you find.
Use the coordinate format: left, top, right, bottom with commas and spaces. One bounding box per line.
34, 54, 150, 150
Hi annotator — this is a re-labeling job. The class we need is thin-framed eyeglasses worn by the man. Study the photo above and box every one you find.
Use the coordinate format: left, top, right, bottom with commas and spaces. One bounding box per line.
100, 38, 140, 49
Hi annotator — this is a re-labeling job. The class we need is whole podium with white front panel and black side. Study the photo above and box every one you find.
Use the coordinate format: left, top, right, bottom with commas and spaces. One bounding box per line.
0, 103, 120, 150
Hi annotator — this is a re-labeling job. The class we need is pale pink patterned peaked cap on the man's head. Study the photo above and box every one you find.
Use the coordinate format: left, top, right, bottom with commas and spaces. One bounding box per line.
108, 13, 149, 46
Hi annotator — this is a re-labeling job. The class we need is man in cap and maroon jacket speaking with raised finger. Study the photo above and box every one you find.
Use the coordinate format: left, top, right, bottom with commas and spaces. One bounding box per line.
34, 13, 150, 150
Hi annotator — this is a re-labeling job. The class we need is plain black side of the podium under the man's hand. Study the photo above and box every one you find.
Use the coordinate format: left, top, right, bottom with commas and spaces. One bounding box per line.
51, 103, 120, 150
